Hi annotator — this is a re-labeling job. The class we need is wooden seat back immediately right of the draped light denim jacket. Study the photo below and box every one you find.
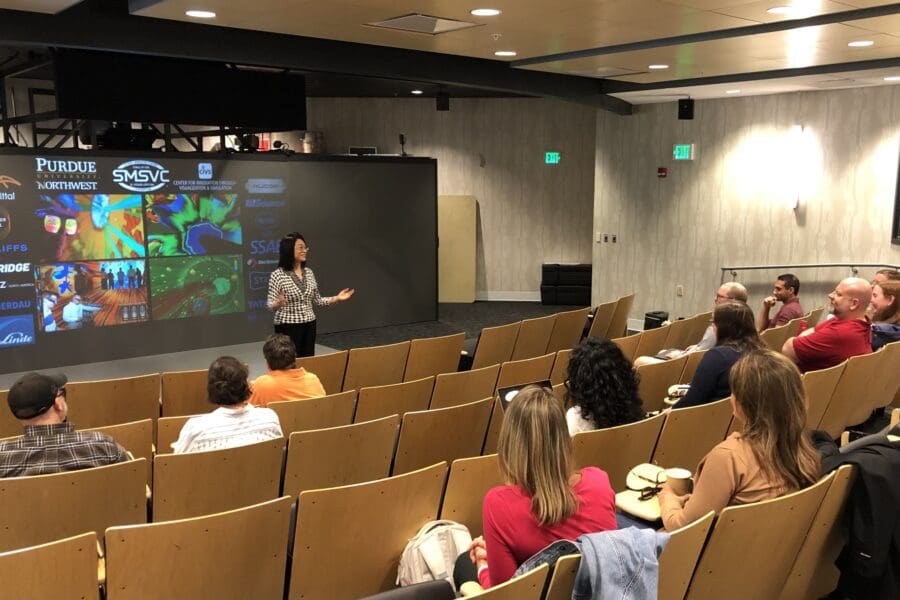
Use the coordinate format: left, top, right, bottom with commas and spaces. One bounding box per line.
657, 511, 716, 600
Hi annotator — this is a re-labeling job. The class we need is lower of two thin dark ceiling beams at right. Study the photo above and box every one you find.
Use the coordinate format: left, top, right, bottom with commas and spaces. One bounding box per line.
602, 57, 900, 94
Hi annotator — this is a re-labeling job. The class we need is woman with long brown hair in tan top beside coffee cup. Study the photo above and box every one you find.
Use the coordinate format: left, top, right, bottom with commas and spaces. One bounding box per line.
659, 350, 820, 531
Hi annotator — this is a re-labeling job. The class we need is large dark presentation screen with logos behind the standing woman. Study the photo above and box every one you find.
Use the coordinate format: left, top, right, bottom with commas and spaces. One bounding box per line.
0, 151, 437, 373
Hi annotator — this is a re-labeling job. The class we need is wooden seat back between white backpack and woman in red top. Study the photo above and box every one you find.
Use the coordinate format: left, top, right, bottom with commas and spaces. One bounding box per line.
440, 454, 503, 537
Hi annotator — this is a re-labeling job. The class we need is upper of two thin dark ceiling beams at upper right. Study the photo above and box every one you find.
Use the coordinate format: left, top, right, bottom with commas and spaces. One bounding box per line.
510, 3, 900, 67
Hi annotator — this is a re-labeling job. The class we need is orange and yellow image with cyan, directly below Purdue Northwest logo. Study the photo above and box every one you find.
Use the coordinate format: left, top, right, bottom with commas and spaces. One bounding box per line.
35, 194, 145, 261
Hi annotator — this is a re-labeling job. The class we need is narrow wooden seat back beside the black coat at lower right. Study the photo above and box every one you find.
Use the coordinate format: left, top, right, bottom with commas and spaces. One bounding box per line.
780, 465, 856, 600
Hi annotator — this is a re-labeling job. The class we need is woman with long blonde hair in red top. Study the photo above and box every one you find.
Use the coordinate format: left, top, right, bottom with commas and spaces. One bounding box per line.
469, 386, 616, 588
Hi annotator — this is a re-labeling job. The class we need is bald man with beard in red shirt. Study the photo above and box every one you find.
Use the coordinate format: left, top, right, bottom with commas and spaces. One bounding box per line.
781, 277, 872, 371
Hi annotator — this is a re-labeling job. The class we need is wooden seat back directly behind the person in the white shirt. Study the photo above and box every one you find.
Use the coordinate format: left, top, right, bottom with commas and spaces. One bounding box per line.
153, 438, 284, 521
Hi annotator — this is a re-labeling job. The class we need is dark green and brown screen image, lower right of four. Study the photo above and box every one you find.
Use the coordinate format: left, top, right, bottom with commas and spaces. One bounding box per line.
150, 255, 245, 319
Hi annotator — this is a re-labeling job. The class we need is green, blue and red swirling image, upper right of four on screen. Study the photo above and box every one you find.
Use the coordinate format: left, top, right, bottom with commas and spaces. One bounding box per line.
144, 193, 242, 256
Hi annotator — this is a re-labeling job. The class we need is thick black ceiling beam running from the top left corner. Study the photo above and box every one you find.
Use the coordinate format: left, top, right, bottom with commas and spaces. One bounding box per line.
0, 1, 632, 115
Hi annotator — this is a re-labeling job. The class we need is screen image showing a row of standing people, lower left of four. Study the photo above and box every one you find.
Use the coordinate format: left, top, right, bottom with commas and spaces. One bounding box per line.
36, 260, 150, 333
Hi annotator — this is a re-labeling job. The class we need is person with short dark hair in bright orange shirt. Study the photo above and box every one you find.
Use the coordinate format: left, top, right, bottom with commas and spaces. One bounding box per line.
250, 333, 325, 406
